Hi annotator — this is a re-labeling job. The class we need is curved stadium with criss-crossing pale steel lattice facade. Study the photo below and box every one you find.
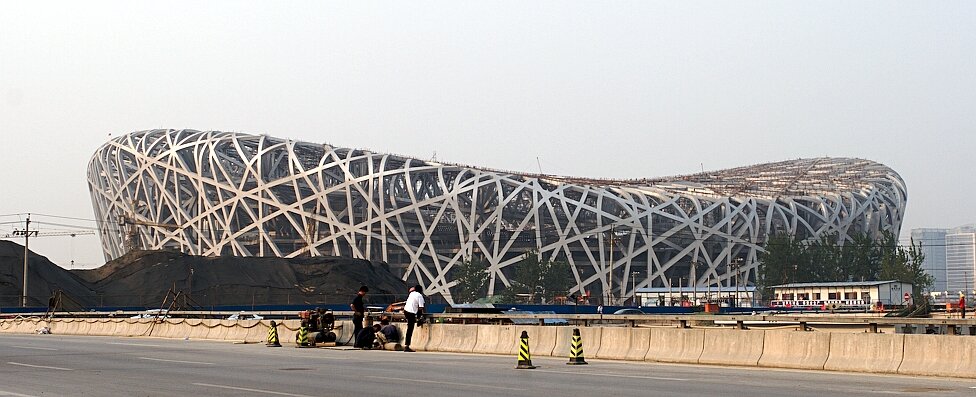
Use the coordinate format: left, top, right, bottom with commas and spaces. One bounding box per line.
88, 130, 907, 301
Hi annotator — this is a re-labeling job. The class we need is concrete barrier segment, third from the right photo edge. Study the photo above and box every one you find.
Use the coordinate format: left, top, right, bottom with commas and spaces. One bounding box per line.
759, 331, 830, 369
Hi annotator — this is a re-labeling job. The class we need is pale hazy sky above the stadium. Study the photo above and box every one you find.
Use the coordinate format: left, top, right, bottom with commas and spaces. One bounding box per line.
0, 1, 976, 267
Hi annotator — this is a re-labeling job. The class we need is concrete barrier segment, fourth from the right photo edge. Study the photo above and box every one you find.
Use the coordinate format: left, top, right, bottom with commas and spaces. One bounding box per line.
698, 329, 766, 366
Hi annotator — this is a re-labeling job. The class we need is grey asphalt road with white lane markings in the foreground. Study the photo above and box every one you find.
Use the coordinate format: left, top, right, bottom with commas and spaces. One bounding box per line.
0, 335, 976, 397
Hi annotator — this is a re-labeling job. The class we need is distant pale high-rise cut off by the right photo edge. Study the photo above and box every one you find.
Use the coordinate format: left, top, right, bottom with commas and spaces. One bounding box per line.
945, 225, 976, 295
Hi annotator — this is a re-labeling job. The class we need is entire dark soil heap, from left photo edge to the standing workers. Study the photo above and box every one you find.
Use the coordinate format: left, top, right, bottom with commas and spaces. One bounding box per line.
0, 241, 407, 309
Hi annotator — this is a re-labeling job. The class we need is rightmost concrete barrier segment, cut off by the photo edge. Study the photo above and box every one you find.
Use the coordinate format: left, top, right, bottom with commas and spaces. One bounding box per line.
898, 335, 976, 378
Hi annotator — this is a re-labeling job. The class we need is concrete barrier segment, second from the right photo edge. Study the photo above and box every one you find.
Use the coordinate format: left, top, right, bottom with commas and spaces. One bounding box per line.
824, 332, 905, 373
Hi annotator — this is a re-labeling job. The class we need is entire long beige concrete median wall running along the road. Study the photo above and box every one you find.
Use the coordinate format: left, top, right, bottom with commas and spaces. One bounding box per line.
9, 318, 976, 378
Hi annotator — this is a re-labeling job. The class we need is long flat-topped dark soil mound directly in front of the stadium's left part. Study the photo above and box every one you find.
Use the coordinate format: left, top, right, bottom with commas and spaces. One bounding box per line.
76, 251, 407, 307
